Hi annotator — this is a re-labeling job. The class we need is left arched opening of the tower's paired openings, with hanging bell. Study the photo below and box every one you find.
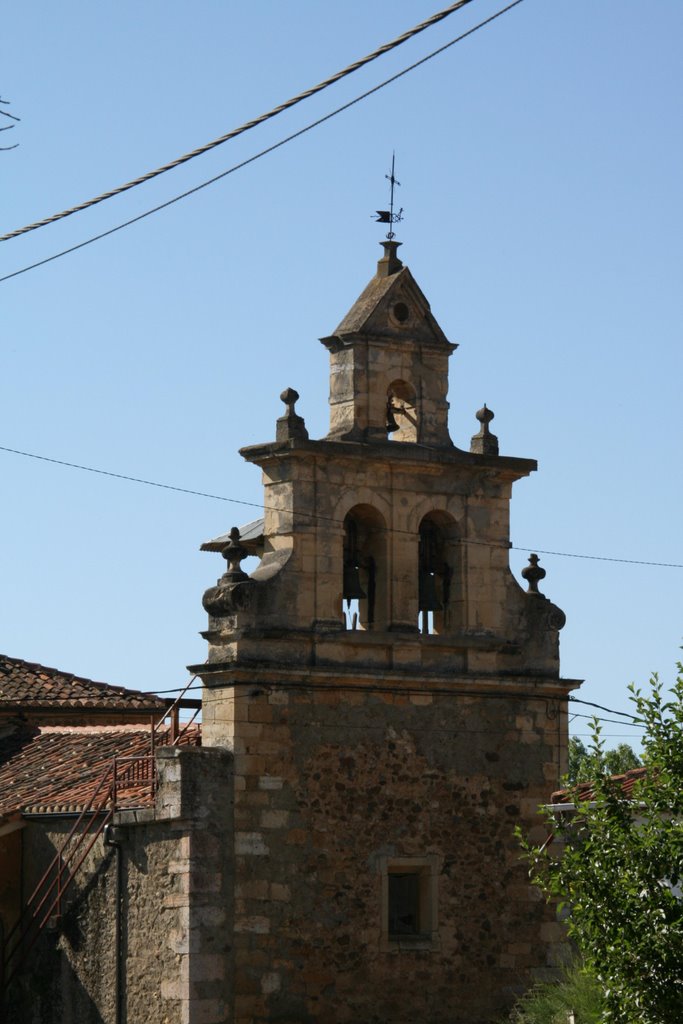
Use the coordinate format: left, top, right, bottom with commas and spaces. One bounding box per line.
342, 505, 387, 630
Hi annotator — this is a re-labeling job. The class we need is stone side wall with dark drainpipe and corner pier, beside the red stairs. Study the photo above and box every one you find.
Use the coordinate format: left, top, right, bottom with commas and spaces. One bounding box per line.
6, 748, 232, 1024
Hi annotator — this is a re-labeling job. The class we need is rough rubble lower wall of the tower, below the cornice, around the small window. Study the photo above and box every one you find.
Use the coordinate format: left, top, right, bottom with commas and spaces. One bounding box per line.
204, 679, 564, 1024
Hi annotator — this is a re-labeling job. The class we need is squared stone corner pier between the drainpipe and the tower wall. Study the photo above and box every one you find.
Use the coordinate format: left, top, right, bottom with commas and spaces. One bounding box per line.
136, 748, 234, 1024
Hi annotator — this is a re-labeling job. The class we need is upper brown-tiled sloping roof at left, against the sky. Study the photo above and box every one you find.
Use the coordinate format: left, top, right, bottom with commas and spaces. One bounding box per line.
0, 654, 166, 713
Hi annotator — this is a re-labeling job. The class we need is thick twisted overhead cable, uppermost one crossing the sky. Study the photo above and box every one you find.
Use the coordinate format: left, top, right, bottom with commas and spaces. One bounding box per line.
0, 0, 481, 242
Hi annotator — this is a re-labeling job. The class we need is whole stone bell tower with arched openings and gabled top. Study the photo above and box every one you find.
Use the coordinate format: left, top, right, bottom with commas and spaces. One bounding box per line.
196, 240, 579, 1024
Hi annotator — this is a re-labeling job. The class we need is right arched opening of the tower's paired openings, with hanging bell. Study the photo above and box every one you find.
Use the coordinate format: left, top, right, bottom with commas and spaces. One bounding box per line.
418, 512, 461, 634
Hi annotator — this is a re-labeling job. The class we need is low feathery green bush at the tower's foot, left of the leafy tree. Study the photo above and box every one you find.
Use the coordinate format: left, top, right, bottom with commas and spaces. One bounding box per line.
501, 966, 603, 1024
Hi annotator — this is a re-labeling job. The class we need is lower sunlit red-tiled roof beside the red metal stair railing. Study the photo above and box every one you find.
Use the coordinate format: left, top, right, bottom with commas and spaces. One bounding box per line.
0, 725, 201, 819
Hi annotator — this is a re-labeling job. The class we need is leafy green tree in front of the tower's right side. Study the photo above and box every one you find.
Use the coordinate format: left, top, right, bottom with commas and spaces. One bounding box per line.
523, 665, 683, 1024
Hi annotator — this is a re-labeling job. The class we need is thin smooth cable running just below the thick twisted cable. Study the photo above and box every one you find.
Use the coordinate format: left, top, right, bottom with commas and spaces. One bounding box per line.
0, 0, 522, 284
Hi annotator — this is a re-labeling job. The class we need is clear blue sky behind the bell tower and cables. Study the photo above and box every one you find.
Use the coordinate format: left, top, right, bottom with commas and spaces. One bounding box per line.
0, 0, 683, 742
